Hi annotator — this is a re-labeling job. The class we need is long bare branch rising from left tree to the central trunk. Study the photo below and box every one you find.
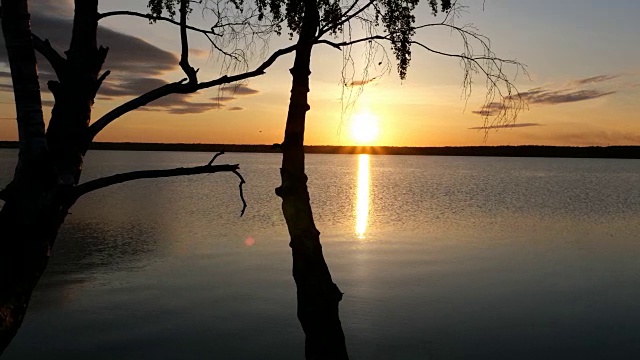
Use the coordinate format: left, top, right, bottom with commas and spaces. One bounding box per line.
86, 45, 296, 143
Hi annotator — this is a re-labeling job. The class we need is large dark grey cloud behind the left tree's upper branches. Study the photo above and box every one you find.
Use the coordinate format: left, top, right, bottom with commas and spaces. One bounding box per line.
0, 0, 248, 115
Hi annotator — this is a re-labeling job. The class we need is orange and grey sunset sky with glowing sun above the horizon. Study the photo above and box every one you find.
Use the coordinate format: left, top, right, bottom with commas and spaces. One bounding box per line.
0, 0, 640, 146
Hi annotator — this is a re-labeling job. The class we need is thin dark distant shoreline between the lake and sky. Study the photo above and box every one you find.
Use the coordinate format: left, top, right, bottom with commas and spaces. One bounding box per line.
0, 141, 640, 159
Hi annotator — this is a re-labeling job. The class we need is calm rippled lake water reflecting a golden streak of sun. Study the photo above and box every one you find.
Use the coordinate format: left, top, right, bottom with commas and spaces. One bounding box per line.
0, 150, 640, 360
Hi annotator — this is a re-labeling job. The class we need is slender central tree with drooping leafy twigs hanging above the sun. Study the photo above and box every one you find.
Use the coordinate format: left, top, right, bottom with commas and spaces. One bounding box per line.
257, 0, 524, 359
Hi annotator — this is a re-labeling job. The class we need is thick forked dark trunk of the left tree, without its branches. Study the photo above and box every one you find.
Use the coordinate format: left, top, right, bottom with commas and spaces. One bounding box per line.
0, 0, 102, 354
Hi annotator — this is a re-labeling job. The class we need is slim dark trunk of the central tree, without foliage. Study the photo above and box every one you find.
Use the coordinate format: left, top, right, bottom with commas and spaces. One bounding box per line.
276, 0, 348, 359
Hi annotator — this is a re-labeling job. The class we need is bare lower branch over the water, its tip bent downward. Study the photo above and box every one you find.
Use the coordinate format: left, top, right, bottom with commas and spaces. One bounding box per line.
70, 164, 247, 215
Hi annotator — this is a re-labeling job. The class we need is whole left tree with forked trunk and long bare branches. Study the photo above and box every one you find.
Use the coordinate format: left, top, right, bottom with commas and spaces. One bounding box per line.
0, 0, 294, 353
